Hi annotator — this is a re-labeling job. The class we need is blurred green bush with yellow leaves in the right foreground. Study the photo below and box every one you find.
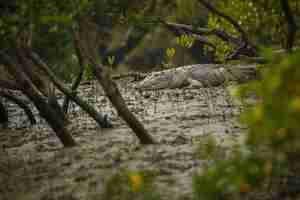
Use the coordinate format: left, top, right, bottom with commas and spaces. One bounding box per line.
194, 48, 300, 199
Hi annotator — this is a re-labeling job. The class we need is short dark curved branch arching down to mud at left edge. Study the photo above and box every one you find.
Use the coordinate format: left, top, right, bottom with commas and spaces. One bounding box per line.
0, 91, 36, 125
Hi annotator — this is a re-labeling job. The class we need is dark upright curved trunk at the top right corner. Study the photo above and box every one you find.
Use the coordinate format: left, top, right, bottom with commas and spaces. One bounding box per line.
280, 0, 297, 51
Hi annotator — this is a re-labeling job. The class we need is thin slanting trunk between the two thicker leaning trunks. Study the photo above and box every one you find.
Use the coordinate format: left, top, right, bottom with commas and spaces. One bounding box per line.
25, 49, 112, 128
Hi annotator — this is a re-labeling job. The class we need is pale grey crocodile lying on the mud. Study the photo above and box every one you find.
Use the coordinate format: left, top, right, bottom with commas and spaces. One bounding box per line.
136, 64, 257, 90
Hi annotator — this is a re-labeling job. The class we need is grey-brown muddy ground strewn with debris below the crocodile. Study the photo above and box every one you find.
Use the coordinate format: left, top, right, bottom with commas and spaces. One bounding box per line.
0, 78, 246, 200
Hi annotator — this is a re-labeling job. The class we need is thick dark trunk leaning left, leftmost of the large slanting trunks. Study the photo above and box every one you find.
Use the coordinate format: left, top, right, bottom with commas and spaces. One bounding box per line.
1, 52, 76, 147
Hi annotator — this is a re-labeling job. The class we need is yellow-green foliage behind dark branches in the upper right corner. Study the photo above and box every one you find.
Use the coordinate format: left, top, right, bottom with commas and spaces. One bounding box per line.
208, 0, 300, 60
